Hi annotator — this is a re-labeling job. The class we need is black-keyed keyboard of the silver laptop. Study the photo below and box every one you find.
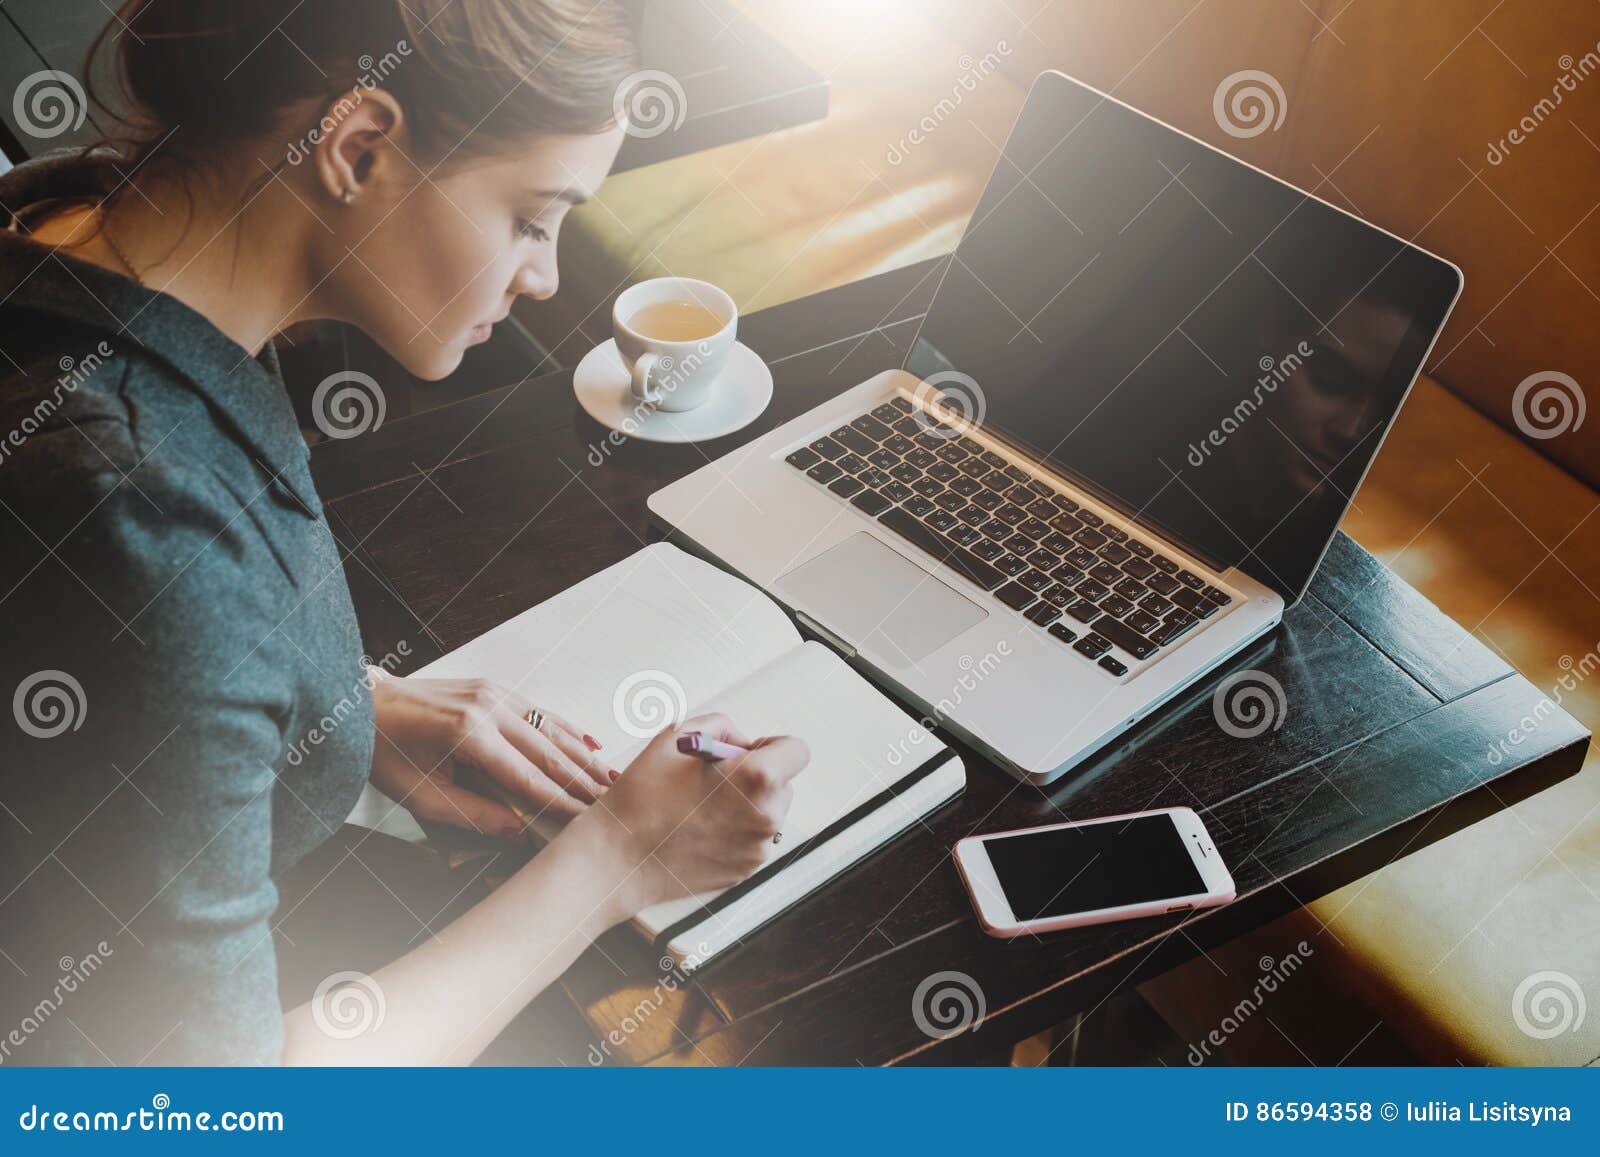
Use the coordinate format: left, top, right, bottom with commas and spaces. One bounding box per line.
784, 397, 1234, 679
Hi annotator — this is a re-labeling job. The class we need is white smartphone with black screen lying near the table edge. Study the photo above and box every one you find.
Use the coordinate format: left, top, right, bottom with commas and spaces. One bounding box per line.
955, 808, 1234, 936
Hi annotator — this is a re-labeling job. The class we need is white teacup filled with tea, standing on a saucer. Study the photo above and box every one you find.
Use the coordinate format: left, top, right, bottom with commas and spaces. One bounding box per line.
611, 277, 739, 413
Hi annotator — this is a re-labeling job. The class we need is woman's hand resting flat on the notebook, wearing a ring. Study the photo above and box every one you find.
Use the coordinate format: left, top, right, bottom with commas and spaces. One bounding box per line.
373, 677, 618, 840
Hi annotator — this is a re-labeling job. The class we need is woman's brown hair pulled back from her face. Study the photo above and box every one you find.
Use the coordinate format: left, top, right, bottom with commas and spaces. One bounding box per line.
86, 0, 637, 180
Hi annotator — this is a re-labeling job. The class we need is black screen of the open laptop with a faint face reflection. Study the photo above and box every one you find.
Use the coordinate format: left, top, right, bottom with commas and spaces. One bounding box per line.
906, 74, 1459, 602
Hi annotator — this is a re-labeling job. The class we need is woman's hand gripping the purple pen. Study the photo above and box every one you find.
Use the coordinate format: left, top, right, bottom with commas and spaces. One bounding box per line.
562, 715, 811, 920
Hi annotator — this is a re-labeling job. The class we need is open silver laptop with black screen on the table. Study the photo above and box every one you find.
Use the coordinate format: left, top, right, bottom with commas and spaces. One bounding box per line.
650, 72, 1462, 784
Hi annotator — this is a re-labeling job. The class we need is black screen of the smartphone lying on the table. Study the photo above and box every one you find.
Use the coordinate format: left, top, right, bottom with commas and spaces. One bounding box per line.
984, 815, 1206, 920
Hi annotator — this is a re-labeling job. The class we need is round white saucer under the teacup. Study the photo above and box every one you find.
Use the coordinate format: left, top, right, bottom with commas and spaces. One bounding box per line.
573, 339, 773, 442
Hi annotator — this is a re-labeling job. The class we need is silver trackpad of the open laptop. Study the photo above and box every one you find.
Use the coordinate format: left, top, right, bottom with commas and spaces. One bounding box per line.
773, 531, 989, 666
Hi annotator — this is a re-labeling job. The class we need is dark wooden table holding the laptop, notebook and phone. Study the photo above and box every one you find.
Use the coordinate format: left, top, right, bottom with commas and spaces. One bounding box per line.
314, 262, 1587, 1064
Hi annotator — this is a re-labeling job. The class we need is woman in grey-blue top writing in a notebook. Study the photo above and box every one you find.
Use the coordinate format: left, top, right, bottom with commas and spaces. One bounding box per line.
0, 0, 806, 1064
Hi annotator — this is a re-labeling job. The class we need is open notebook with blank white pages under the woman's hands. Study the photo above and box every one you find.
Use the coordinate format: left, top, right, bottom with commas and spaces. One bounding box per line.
350, 542, 966, 968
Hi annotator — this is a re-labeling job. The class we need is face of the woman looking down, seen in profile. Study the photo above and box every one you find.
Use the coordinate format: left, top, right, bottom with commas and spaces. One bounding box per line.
318, 128, 622, 381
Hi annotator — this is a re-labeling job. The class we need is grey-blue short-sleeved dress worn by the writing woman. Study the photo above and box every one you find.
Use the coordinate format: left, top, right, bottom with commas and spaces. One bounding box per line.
0, 162, 373, 1064
